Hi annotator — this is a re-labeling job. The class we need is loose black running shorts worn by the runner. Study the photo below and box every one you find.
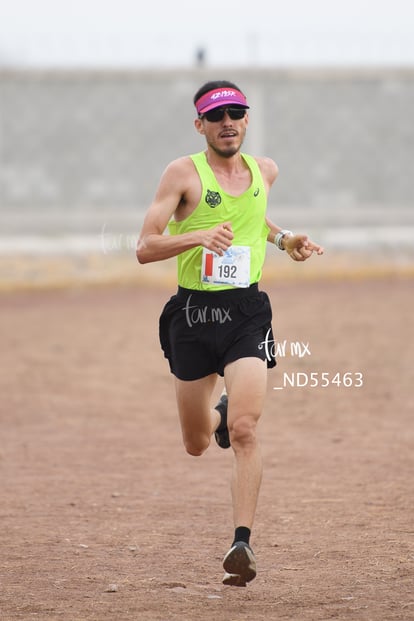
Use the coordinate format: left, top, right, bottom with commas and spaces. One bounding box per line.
159, 284, 276, 380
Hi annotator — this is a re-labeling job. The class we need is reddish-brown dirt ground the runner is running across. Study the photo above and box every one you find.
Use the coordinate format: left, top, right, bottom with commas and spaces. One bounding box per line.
0, 277, 414, 621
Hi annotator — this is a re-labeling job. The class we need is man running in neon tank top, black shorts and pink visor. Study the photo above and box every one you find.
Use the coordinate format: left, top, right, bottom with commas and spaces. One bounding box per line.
137, 80, 323, 586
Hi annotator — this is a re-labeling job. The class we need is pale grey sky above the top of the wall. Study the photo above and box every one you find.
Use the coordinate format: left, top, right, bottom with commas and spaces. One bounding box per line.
0, 0, 414, 68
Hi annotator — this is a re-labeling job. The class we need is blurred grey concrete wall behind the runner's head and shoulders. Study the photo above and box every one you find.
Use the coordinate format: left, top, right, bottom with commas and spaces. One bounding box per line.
0, 70, 414, 228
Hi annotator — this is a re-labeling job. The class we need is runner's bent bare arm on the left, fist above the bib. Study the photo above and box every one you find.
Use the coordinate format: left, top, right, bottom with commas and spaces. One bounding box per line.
136, 158, 233, 263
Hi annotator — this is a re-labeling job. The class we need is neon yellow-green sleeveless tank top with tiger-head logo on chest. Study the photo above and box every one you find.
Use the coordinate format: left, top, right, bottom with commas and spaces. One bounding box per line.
168, 151, 270, 291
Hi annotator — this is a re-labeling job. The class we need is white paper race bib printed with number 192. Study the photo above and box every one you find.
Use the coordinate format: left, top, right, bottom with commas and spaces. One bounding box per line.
201, 246, 250, 287
